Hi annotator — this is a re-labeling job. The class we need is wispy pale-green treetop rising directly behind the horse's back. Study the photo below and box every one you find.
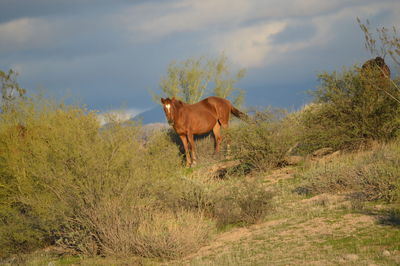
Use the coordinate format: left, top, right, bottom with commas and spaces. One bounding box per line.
155, 54, 245, 105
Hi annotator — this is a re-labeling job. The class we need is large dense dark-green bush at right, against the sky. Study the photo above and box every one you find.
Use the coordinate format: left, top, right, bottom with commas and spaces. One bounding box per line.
298, 67, 400, 153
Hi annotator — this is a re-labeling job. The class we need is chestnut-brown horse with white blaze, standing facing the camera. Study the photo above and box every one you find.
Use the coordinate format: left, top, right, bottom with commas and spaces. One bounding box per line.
161, 97, 247, 166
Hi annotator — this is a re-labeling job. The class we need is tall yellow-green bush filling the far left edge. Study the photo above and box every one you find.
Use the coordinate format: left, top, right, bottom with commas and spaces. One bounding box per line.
0, 97, 99, 256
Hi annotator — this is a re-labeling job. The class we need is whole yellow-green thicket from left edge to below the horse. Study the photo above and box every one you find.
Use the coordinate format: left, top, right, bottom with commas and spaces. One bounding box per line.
0, 95, 278, 259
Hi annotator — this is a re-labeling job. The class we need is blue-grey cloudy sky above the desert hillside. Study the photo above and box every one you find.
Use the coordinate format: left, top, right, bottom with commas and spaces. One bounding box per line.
0, 0, 400, 114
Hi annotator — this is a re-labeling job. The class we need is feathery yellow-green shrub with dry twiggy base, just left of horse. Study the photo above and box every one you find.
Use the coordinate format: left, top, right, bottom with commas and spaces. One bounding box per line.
47, 124, 198, 258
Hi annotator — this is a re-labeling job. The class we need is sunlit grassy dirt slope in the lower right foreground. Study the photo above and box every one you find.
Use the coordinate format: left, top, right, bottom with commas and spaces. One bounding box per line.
7, 163, 400, 265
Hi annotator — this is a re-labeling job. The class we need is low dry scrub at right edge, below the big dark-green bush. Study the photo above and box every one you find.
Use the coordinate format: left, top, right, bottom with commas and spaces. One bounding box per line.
300, 141, 400, 202
